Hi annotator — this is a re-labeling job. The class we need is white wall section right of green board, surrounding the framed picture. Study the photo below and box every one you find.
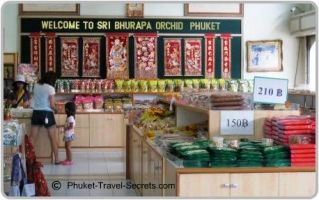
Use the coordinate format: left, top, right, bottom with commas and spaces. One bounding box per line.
242, 3, 298, 88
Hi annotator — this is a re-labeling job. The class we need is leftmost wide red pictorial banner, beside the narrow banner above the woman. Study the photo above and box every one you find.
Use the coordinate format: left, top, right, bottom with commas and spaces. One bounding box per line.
61, 37, 79, 77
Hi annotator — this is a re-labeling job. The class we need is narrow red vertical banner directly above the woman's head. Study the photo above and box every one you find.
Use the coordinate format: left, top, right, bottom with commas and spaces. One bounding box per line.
45, 33, 56, 72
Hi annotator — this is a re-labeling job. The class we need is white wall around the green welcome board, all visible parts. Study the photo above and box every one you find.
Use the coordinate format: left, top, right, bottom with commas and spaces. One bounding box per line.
2, 2, 308, 88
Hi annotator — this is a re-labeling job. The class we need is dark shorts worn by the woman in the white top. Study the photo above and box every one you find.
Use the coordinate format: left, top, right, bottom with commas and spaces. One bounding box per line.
31, 110, 56, 128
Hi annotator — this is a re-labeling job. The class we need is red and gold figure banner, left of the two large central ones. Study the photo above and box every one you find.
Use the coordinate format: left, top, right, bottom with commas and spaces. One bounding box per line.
106, 33, 129, 79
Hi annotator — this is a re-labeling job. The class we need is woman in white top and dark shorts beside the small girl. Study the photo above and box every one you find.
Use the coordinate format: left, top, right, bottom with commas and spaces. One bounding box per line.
31, 71, 60, 164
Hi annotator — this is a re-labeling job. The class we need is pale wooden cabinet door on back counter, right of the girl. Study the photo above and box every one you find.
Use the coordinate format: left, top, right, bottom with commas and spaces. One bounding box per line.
90, 114, 124, 147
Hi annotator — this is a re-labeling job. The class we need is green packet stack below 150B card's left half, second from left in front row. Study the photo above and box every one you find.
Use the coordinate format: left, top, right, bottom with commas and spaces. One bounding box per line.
208, 147, 237, 167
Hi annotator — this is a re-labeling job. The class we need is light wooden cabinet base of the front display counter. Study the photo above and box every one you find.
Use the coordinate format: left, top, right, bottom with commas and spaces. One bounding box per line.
127, 126, 317, 198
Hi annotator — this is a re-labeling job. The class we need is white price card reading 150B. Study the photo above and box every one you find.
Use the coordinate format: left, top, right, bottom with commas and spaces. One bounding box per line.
220, 110, 254, 135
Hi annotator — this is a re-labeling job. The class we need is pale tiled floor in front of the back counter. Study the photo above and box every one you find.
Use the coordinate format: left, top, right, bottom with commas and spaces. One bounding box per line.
42, 151, 136, 197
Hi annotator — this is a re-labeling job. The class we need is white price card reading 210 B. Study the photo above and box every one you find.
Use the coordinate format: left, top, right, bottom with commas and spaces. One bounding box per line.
254, 77, 288, 104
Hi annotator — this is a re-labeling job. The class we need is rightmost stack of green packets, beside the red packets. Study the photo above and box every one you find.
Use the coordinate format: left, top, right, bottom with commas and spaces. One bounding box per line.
263, 145, 290, 167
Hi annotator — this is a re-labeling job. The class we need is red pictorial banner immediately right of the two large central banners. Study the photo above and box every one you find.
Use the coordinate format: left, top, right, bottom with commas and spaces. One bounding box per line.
164, 38, 182, 76
